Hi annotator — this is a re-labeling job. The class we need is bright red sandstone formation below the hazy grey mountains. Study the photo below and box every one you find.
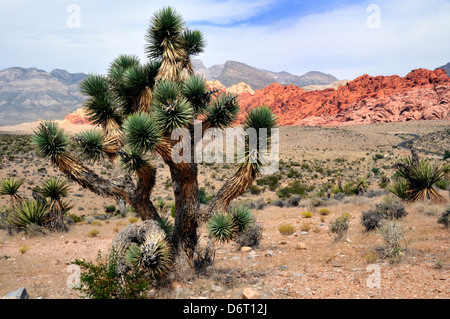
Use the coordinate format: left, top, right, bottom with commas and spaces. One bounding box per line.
62, 69, 450, 126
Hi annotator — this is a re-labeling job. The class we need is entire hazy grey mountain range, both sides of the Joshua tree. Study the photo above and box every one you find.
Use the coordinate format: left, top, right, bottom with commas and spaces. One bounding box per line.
0, 60, 450, 126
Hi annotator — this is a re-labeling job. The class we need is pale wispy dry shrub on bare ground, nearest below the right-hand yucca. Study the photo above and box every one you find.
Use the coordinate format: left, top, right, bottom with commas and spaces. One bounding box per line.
379, 220, 403, 263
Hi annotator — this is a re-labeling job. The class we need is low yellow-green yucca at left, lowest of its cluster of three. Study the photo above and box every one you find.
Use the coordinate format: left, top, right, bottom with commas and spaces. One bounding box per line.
9, 199, 51, 232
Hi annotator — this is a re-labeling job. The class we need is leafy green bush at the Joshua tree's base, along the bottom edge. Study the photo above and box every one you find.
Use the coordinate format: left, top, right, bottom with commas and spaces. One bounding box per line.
74, 250, 149, 299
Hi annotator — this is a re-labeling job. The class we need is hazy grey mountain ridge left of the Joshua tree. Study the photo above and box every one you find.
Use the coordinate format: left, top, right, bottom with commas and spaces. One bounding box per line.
0, 67, 86, 126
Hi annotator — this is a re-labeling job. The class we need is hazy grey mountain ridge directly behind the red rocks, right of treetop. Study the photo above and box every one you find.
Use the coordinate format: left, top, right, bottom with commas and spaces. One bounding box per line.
193, 60, 339, 90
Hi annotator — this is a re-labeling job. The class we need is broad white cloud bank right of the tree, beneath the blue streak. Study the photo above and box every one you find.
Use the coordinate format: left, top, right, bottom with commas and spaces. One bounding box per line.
198, 0, 450, 78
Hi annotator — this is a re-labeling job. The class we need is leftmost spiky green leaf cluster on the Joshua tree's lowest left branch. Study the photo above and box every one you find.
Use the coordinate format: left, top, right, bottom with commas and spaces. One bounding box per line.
31, 122, 69, 161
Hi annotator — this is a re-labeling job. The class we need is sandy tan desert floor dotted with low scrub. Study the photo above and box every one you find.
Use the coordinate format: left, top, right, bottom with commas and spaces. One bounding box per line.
0, 120, 450, 299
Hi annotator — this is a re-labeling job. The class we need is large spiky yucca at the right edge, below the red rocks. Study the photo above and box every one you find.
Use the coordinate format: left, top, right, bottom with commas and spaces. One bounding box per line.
389, 148, 445, 202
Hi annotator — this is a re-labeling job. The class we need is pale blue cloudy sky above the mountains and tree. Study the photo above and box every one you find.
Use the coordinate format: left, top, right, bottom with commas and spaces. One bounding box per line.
0, 0, 450, 79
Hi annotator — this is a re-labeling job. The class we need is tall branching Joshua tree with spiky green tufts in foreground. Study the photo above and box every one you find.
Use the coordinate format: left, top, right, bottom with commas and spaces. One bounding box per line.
33, 7, 276, 266
